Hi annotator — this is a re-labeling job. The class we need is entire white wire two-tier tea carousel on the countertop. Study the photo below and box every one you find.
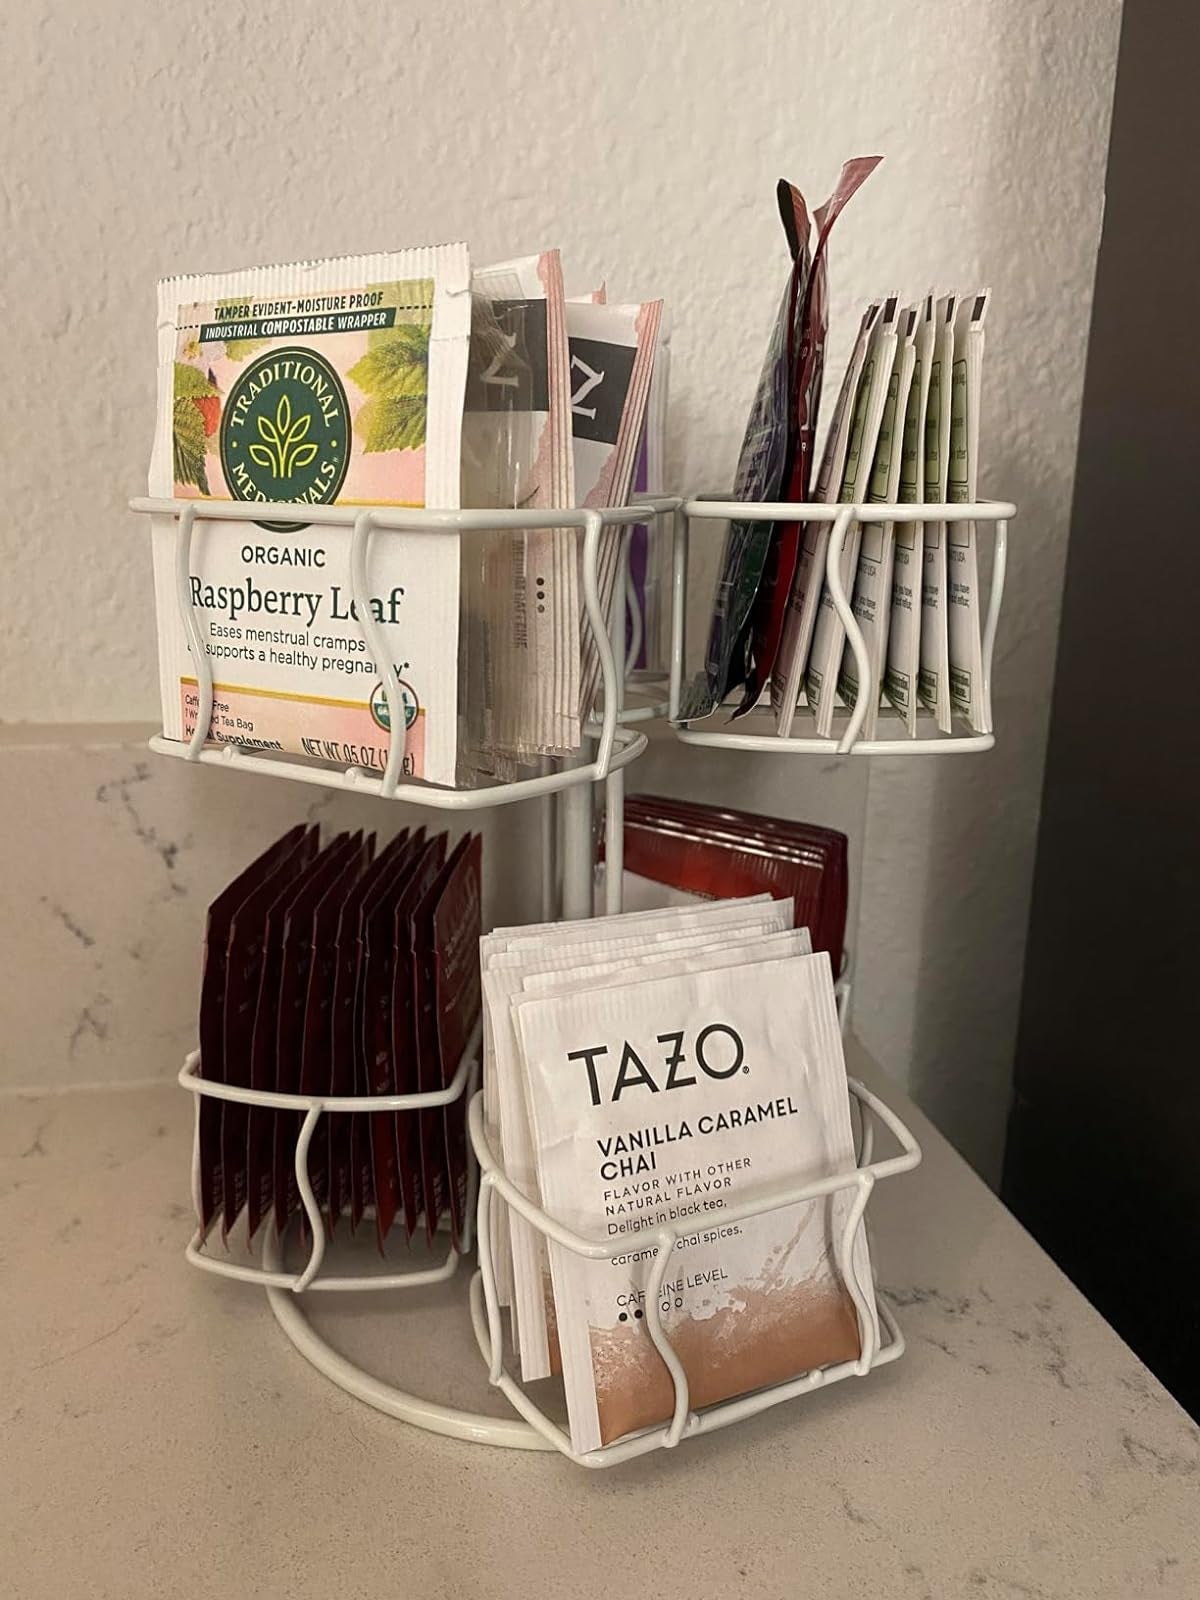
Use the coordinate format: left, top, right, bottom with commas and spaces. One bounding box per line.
133, 498, 985, 1467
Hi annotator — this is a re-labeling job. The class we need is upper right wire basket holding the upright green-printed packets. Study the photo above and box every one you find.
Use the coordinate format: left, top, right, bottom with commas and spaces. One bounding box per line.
669, 496, 1016, 757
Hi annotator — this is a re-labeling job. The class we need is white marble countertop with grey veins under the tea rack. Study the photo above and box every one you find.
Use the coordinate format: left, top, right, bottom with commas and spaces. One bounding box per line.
0, 1062, 1200, 1600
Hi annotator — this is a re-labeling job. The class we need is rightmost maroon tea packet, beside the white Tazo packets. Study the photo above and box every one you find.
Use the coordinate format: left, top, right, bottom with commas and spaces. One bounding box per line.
432, 834, 483, 1250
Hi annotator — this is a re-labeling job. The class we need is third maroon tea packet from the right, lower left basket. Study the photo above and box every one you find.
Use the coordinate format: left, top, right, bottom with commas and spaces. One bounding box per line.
350, 827, 426, 1253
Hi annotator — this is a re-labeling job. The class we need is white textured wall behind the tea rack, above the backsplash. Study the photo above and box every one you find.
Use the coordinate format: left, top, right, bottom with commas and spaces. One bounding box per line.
0, 0, 1118, 1177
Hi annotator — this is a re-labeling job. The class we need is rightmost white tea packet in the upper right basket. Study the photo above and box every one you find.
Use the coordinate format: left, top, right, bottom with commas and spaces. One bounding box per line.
946, 290, 992, 733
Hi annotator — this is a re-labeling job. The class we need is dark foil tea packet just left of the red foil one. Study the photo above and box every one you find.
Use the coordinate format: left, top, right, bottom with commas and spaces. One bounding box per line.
680, 182, 810, 722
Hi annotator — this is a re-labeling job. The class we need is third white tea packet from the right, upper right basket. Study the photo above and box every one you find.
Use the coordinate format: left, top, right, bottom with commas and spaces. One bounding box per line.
883, 294, 936, 738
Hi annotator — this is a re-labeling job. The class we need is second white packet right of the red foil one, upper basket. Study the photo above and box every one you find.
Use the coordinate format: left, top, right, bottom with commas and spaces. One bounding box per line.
805, 296, 899, 739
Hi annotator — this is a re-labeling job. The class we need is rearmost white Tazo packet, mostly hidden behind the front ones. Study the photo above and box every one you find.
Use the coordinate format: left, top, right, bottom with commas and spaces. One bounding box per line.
482, 898, 792, 1381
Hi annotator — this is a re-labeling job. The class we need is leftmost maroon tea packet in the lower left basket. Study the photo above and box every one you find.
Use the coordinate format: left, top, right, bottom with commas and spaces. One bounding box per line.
221, 827, 318, 1237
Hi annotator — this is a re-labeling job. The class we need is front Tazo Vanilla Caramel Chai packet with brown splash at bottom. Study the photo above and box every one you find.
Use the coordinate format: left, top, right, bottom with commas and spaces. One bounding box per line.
514, 954, 875, 1453
